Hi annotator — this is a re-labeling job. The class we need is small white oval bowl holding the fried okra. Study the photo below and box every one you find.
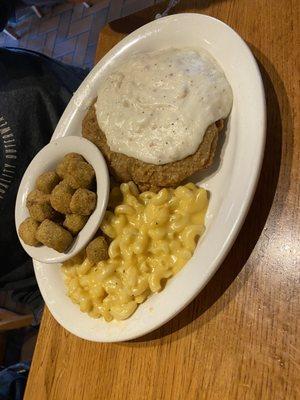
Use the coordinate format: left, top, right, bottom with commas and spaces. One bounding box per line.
15, 136, 109, 264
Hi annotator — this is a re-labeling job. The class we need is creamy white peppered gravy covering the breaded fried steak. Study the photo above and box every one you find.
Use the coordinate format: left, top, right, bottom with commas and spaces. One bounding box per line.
95, 48, 232, 165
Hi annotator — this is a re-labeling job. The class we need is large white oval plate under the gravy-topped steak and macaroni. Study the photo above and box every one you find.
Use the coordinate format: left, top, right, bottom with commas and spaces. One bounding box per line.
34, 14, 266, 342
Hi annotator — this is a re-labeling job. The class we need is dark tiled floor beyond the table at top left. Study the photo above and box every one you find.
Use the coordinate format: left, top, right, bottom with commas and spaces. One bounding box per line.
0, 0, 162, 68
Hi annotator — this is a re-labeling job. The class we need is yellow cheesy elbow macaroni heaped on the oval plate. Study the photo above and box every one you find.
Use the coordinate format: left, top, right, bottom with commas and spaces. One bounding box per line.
62, 182, 208, 321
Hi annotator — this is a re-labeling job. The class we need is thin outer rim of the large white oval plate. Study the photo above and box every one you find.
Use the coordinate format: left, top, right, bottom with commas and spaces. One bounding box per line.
33, 13, 266, 342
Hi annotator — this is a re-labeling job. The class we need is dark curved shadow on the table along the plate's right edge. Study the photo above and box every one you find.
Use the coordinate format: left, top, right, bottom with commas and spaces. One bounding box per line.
123, 46, 293, 346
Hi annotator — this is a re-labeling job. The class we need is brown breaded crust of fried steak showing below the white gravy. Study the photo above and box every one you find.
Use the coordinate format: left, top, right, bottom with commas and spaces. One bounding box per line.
82, 104, 223, 191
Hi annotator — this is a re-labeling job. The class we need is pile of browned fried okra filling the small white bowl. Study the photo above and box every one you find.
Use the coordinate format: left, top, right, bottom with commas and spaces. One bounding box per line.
19, 153, 97, 248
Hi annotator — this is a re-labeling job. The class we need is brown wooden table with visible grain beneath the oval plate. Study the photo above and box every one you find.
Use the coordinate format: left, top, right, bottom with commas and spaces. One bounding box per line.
25, 0, 300, 400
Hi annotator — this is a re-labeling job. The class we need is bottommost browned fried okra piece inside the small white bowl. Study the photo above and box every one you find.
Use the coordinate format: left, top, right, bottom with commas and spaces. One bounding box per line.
36, 219, 73, 253
